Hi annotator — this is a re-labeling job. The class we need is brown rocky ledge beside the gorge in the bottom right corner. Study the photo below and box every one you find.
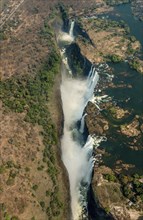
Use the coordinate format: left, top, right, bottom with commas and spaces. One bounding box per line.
92, 166, 140, 220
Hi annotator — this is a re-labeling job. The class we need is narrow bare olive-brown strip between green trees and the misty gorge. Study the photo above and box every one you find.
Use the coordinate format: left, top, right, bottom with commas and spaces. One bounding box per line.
48, 60, 71, 219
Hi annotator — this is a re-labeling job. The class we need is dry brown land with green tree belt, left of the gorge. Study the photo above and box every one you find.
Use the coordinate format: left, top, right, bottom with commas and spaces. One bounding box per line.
0, 4, 70, 220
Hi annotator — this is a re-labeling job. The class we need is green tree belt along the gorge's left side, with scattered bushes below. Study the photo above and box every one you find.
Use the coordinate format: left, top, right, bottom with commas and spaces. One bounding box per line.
0, 22, 62, 219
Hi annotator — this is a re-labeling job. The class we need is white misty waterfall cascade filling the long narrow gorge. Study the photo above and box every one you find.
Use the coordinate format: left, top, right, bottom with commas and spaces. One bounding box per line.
61, 22, 99, 220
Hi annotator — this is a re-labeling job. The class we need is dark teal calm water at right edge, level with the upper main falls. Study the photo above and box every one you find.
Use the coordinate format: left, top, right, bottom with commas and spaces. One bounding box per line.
107, 62, 143, 115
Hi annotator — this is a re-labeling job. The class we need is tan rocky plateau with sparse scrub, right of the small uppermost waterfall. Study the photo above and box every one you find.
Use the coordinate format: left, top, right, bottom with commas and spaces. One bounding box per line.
77, 17, 141, 63
